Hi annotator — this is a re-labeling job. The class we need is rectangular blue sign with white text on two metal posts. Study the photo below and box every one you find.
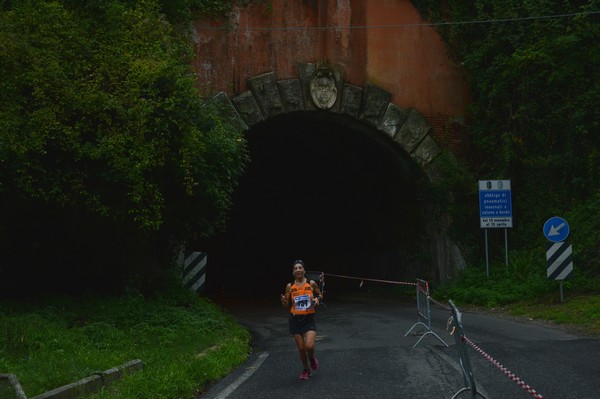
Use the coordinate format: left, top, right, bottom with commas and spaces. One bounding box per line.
479, 180, 513, 277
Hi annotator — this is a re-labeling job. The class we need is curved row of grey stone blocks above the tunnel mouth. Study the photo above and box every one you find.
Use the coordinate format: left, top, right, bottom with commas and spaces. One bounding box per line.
211, 63, 441, 178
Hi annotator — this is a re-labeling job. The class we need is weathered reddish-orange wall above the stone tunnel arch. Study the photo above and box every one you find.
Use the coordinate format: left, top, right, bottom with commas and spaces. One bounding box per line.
194, 0, 469, 153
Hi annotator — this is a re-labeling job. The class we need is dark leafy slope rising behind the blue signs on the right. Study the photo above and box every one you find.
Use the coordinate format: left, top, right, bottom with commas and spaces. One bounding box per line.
413, 0, 600, 276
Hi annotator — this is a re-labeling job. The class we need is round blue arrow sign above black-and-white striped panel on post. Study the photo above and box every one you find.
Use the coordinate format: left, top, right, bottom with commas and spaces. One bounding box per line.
544, 216, 573, 303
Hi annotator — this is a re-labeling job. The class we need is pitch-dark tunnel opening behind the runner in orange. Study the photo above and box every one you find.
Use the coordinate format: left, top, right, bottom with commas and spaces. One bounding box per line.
197, 112, 429, 298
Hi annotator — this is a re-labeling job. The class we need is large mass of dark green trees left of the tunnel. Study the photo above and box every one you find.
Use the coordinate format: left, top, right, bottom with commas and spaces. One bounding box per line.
0, 0, 247, 293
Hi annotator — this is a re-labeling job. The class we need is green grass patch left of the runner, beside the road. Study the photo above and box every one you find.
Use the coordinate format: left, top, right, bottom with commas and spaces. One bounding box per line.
0, 290, 250, 399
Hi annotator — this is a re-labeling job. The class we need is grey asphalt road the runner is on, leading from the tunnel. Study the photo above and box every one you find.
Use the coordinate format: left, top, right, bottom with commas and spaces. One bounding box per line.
200, 291, 600, 399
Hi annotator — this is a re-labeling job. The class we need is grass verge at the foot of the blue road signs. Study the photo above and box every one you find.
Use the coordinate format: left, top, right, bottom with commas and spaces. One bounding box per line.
431, 253, 600, 336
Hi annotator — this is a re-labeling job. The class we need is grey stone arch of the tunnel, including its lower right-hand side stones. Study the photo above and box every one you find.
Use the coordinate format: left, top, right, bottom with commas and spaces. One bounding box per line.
210, 63, 465, 281
